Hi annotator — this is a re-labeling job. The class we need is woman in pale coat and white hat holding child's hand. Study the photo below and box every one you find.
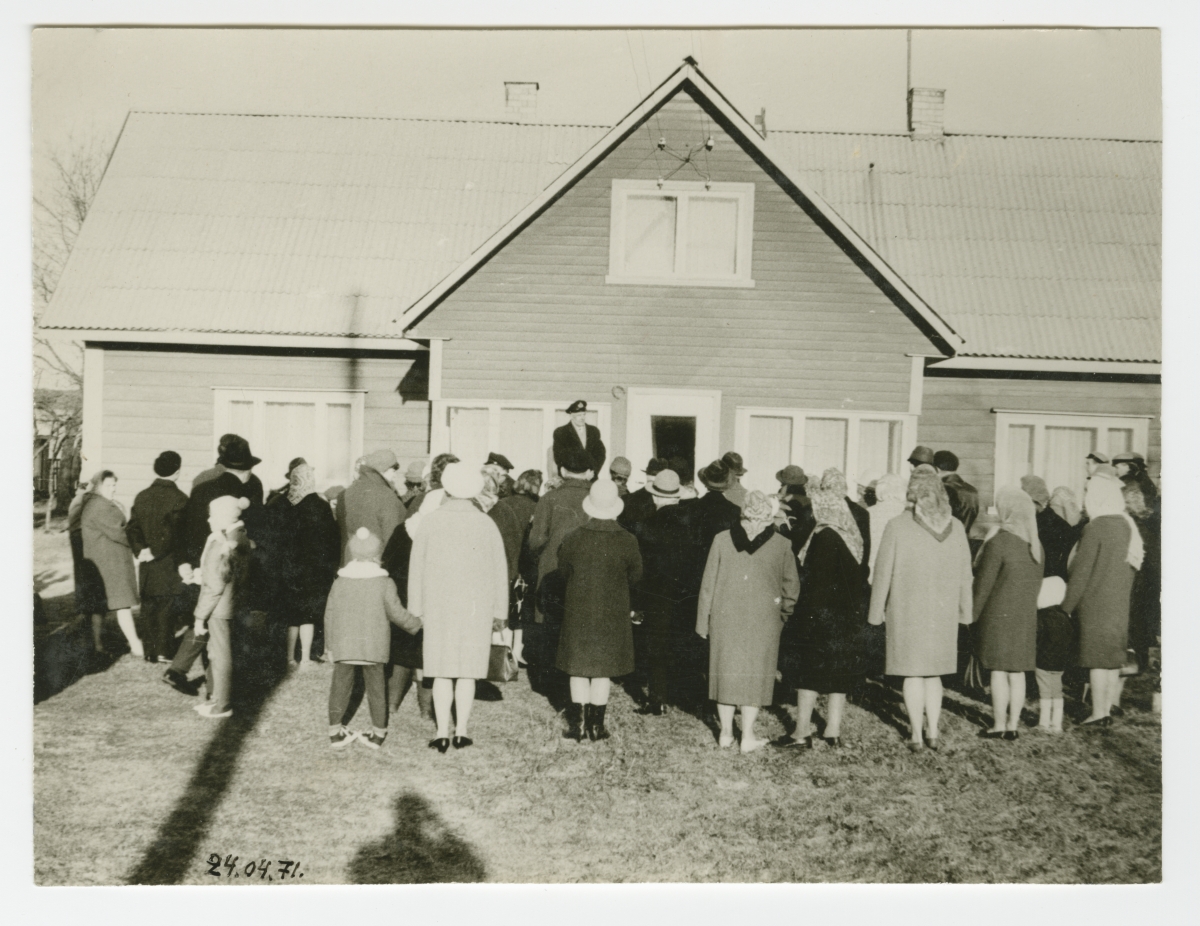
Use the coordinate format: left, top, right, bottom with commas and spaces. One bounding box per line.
408, 463, 509, 753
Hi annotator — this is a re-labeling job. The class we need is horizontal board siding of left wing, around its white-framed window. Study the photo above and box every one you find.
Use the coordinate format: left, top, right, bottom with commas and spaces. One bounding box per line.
102, 350, 430, 504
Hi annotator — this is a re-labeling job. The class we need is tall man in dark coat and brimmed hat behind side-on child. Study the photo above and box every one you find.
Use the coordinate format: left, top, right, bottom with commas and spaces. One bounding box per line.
162, 434, 263, 695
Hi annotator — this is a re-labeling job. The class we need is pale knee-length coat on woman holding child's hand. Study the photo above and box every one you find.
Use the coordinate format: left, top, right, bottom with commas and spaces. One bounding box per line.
408, 498, 509, 679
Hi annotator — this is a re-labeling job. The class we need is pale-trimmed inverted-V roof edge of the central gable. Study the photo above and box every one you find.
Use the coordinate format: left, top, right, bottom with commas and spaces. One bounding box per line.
397, 59, 965, 356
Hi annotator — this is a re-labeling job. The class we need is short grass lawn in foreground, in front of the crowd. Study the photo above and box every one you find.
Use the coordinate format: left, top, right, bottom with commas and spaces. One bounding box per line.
34, 535, 1162, 884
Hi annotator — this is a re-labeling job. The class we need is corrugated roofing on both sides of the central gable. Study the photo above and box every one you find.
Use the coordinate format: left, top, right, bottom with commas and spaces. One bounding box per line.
42, 113, 1162, 361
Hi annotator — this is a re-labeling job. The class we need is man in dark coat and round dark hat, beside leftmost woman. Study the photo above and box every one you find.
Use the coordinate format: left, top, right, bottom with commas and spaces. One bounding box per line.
125, 450, 187, 662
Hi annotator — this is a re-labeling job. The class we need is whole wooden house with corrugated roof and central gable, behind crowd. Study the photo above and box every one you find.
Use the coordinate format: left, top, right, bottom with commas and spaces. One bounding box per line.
43, 61, 1160, 510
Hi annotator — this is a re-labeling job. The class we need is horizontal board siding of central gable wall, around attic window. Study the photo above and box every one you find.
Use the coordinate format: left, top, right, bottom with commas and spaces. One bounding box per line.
418, 94, 936, 447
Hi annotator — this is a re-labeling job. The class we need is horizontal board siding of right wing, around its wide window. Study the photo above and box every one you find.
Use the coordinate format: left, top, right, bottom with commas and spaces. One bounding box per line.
918, 377, 1162, 505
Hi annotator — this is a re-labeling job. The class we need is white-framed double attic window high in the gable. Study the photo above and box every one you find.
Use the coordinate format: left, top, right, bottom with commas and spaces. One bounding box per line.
605, 180, 754, 287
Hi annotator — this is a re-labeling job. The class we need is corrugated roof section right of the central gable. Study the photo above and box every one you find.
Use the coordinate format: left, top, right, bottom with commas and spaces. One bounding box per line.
769, 132, 1162, 361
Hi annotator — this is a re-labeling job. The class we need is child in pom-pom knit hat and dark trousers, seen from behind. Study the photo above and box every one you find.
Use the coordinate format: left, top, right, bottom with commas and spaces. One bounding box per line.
325, 528, 421, 750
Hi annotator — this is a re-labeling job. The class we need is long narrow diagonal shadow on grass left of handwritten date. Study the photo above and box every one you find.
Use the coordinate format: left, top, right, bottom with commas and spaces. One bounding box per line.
125, 618, 286, 884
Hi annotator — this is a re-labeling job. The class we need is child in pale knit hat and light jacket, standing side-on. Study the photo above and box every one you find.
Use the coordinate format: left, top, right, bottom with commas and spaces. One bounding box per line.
192, 495, 250, 720
